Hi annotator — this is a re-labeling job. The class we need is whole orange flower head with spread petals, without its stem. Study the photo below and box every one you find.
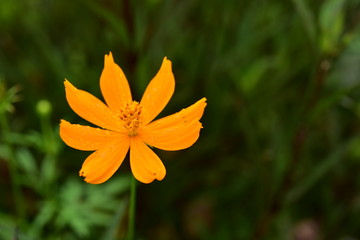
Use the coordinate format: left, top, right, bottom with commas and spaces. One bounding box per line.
60, 52, 206, 184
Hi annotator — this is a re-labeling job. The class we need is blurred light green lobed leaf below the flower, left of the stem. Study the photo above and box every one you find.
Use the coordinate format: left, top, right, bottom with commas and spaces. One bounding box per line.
55, 176, 129, 238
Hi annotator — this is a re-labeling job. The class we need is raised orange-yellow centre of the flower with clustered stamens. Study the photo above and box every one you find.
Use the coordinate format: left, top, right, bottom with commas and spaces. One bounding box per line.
120, 101, 142, 137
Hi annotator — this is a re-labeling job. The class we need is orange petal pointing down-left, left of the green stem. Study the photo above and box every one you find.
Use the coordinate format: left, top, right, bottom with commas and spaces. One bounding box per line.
79, 135, 130, 184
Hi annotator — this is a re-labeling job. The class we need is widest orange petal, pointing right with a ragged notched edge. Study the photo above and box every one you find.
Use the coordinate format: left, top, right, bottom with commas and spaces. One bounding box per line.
139, 98, 206, 151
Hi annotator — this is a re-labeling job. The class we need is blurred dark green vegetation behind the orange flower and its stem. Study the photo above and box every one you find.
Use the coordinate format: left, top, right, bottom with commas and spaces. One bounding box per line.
0, 0, 360, 240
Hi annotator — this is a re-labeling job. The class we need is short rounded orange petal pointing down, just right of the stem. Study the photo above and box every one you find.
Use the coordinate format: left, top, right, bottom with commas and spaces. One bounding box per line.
130, 137, 166, 183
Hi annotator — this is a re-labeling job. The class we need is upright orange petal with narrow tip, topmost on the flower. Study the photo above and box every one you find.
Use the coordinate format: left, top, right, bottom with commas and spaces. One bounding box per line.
100, 52, 132, 112
